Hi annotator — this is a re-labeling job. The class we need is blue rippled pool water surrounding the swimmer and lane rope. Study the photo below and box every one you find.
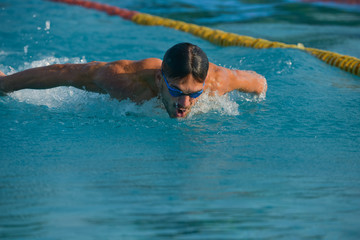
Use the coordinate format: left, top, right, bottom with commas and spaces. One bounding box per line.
0, 0, 360, 240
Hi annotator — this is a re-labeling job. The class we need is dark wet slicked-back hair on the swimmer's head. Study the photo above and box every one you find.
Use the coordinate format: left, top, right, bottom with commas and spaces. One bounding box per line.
162, 43, 209, 83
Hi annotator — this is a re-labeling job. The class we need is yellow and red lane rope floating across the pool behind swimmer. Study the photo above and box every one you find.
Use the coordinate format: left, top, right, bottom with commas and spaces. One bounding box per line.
50, 0, 360, 76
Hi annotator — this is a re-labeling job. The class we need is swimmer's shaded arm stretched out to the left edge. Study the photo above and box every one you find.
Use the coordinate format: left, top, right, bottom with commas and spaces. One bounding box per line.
0, 62, 105, 93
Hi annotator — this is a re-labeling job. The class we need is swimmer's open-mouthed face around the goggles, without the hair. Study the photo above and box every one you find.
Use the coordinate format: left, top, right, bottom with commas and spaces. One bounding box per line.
157, 71, 204, 118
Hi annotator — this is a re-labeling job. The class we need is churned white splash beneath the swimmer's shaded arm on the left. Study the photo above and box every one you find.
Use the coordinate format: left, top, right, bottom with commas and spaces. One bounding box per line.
9, 87, 167, 117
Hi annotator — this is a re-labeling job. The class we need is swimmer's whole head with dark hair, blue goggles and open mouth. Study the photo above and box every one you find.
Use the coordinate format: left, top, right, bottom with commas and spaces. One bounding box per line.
157, 43, 209, 118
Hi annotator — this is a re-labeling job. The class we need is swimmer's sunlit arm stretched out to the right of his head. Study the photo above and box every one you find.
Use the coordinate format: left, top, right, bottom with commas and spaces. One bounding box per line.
209, 63, 267, 95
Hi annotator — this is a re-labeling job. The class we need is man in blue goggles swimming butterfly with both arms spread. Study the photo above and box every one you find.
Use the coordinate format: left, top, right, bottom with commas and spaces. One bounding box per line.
0, 43, 267, 118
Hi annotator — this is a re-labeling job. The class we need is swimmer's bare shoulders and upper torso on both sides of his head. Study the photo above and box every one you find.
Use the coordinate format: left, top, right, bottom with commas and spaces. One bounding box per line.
95, 58, 232, 102
